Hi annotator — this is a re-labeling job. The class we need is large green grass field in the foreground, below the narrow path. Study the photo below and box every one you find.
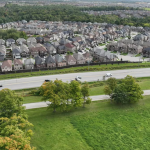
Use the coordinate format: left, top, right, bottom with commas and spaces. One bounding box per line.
27, 96, 150, 150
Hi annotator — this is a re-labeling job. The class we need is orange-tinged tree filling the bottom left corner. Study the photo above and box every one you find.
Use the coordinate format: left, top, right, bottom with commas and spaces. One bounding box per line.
0, 114, 34, 150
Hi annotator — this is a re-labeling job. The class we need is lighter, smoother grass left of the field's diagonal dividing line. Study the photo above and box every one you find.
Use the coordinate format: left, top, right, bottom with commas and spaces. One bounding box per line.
27, 108, 92, 150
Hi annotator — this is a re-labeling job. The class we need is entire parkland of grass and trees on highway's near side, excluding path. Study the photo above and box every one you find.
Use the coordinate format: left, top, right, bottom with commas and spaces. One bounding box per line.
0, 76, 150, 150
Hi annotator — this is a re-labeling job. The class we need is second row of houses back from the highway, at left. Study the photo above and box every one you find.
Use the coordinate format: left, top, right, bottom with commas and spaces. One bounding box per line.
0, 37, 86, 61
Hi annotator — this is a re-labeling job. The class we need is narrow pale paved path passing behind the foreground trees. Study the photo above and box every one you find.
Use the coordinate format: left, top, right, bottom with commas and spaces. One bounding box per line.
23, 90, 150, 109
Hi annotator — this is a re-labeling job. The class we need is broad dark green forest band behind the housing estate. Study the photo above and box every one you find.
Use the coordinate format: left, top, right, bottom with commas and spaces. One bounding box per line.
0, 4, 150, 26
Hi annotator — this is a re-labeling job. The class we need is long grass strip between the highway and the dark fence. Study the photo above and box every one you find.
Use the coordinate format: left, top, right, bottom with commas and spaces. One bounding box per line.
0, 62, 150, 80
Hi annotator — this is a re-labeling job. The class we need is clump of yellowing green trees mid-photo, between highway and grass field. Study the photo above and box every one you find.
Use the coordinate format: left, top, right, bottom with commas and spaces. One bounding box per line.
31, 80, 91, 112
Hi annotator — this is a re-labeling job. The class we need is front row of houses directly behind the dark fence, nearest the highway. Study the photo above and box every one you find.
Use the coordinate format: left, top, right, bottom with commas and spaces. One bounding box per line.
1, 52, 93, 72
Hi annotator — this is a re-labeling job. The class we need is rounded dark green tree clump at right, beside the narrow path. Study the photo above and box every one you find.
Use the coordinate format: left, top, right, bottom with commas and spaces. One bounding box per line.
104, 75, 143, 104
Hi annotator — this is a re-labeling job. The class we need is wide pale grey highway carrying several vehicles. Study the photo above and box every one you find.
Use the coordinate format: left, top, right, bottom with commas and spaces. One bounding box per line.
0, 68, 150, 90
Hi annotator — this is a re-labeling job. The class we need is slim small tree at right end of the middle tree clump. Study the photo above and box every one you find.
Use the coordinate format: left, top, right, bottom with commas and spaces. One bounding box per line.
81, 82, 91, 107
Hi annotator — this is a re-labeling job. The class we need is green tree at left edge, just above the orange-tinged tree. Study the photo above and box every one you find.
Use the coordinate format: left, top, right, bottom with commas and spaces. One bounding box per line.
0, 89, 26, 118
